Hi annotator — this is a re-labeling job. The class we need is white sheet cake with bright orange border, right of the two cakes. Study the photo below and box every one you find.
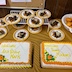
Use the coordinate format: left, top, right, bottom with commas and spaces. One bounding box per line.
40, 42, 72, 68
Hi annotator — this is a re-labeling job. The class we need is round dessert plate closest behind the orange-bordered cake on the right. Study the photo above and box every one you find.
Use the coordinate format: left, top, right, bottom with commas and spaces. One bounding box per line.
49, 29, 65, 41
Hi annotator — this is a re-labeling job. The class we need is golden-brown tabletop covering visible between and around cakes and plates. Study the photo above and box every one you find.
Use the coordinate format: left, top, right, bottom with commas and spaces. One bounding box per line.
0, 20, 72, 72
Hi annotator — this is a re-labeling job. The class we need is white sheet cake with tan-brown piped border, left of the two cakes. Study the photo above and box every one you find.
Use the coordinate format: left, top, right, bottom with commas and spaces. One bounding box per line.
0, 42, 32, 68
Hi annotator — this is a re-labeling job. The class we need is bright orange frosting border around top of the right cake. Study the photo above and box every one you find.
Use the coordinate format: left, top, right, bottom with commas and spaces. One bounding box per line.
42, 42, 72, 66
